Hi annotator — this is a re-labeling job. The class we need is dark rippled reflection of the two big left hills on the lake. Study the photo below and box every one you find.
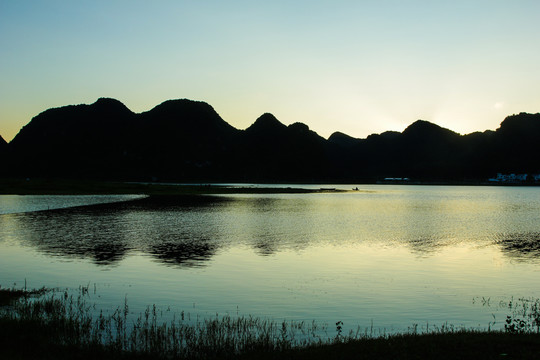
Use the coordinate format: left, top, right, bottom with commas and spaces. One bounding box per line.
4, 197, 230, 267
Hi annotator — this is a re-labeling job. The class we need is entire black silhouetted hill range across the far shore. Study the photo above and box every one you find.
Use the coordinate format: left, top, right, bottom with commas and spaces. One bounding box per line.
0, 98, 540, 182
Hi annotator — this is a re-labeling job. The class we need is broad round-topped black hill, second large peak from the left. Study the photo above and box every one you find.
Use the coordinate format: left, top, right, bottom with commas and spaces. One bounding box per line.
135, 99, 240, 180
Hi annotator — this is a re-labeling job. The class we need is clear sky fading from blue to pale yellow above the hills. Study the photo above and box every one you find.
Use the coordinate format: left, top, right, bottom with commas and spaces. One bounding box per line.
0, 0, 540, 141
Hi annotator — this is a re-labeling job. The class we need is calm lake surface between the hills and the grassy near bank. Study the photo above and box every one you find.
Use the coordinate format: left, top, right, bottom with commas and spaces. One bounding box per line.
0, 185, 540, 332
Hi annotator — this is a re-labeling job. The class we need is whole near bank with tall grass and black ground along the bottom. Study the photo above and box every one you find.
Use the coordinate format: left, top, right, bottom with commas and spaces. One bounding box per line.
0, 287, 540, 359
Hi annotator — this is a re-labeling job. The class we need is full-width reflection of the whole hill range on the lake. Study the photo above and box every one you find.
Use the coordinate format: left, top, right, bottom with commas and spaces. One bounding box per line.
0, 188, 540, 267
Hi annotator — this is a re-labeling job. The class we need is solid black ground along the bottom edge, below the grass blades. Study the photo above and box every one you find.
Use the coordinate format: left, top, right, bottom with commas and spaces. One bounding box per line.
0, 321, 540, 360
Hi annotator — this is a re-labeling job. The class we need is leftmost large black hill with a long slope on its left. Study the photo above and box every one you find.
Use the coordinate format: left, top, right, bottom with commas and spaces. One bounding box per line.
9, 98, 135, 177
